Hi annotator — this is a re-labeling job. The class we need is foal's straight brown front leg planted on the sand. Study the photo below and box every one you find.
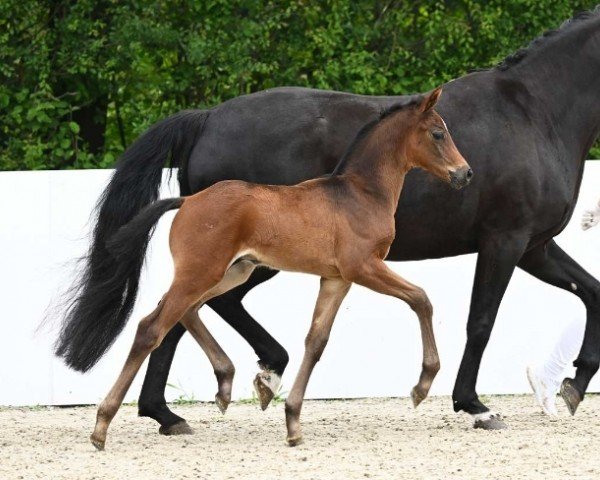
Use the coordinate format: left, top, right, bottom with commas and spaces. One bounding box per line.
285, 278, 352, 447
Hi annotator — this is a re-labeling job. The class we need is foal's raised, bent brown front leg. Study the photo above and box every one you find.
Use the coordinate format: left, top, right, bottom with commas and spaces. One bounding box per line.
352, 260, 440, 407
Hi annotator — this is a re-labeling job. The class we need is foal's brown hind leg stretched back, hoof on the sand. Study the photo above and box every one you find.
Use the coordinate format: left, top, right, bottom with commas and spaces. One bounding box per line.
90, 284, 206, 450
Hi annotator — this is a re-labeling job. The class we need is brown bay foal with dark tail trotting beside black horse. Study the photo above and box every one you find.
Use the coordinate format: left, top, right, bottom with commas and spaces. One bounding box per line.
91, 88, 472, 449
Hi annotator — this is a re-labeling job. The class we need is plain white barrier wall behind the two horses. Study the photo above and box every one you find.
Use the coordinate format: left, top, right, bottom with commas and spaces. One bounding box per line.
0, 162, 600, 405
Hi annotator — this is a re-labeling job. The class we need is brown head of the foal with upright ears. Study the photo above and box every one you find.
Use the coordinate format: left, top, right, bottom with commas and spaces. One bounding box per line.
404, 87, 473, 189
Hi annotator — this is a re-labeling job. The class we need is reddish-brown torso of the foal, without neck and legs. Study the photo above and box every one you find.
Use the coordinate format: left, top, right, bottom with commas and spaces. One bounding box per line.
171, 177, 365, 277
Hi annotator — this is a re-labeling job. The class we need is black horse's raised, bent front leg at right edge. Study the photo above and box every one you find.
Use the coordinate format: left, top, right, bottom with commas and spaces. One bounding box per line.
519, 240, 600, 415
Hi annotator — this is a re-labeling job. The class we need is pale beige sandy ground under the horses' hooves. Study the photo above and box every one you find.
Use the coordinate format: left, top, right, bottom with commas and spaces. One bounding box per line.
0, 396, 600, 480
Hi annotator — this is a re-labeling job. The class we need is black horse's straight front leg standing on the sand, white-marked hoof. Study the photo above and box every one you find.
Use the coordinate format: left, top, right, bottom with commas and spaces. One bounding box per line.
452, 236, 528, 430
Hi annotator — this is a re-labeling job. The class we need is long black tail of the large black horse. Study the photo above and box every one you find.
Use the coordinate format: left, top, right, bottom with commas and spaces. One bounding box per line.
55, 110, 208, 372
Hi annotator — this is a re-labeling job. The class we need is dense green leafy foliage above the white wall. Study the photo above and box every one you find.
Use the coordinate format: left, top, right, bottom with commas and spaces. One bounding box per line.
0, 0, 600, 170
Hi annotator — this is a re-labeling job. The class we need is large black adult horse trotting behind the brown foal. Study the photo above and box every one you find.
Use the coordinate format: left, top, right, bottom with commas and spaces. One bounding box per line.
57, 8, 600, 433
